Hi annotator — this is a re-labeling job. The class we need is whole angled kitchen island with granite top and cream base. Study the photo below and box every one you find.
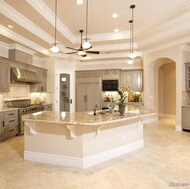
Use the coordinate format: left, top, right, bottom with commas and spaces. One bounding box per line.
23, 106, 157, 169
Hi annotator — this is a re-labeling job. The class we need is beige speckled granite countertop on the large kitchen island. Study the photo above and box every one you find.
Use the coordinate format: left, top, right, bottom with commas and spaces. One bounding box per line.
23, 106, 156, 126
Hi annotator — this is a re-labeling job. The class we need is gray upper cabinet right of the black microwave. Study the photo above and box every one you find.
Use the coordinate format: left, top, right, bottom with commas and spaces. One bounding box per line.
120, 70, 143, 92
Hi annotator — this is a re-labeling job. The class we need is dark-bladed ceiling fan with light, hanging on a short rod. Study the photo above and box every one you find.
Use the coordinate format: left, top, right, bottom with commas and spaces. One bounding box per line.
66, 30, 100, 57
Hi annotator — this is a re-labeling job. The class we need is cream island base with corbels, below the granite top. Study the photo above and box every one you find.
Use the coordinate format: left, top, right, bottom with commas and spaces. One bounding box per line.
24, 117, 154, 169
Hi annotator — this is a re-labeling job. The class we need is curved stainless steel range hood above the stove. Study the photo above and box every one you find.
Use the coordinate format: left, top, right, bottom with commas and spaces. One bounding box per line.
11, 67, 41, 84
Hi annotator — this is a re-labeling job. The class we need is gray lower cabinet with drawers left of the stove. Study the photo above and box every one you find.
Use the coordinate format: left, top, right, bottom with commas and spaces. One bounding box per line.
0, 110, 18, 140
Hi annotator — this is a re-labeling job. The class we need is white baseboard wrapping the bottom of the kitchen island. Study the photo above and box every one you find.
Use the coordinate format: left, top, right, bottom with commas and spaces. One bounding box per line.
24, 139, 144, 169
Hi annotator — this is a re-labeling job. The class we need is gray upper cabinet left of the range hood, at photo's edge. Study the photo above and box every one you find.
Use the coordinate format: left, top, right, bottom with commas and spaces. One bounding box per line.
0, 61, 10, 92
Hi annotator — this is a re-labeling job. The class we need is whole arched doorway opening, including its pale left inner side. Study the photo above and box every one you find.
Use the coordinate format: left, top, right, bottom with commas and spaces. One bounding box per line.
144, 58, 177, 122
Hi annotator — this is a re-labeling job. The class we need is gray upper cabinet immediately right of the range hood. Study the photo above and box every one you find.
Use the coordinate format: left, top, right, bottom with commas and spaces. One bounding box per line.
30, 68, 47, 92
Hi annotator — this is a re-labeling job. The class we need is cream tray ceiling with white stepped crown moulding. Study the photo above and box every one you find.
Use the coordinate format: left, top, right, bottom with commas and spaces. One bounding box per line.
0, 0, 190, 61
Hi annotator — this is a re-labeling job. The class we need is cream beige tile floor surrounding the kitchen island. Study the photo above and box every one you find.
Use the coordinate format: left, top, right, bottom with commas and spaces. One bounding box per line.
0, 119, 190, 189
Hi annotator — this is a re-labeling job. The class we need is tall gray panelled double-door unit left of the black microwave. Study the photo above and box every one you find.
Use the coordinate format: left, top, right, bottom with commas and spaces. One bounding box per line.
76, 78, 101, 112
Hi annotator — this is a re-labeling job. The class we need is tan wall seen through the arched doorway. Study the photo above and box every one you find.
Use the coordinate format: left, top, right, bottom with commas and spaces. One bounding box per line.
158, 63, 176, 118
